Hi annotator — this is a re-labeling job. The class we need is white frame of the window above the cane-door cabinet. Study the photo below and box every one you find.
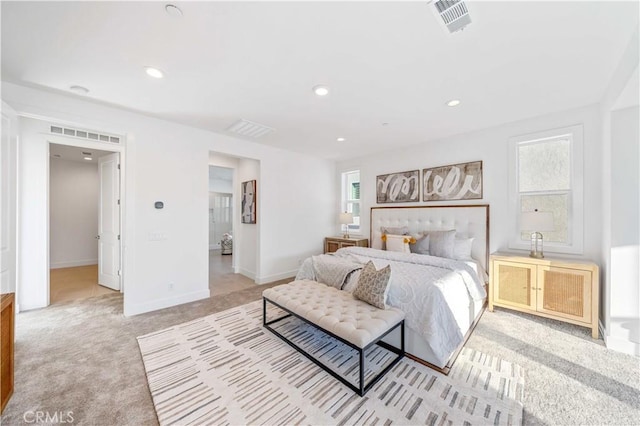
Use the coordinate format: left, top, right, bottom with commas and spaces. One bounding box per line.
508, 124, 584, 254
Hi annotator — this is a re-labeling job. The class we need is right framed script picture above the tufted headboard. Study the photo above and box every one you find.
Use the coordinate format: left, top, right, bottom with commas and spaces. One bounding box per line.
422, 161, 482, 201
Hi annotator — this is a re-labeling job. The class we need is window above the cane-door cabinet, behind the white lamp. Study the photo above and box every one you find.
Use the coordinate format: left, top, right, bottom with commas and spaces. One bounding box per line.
509, 126, 583, 253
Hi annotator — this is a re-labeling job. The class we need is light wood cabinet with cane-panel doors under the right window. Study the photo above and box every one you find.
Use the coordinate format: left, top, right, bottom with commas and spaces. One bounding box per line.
489, 253, 600, 339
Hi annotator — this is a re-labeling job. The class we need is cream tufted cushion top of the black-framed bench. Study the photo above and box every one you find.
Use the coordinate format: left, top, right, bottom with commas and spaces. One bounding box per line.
262, 280, 404, 348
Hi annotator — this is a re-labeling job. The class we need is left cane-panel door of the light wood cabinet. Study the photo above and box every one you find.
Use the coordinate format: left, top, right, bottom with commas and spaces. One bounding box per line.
492, 261, 536, 308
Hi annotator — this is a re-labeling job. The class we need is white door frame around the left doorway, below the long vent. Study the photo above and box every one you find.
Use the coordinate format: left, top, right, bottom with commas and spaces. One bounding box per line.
45, 136, 127, 300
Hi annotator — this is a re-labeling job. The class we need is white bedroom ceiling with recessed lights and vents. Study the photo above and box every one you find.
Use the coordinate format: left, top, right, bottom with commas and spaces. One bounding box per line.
1, 1, 638, 159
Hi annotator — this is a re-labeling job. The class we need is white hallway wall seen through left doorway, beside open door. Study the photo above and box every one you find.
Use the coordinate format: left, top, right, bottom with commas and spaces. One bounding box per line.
49, 157, 100, 269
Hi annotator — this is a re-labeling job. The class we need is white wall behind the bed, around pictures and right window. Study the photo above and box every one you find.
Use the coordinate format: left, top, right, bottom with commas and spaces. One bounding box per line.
336, 105, 602, 262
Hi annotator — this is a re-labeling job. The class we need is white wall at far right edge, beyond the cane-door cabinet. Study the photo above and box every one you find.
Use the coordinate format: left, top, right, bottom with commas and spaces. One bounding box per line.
600, 29, 640, 355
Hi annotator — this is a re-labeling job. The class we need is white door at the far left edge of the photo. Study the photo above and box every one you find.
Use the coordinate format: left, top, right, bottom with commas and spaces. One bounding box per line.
0, 102, 18, 293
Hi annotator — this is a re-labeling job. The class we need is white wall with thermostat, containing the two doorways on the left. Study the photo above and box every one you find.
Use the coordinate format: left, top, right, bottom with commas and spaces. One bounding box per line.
2, 82, 336, 315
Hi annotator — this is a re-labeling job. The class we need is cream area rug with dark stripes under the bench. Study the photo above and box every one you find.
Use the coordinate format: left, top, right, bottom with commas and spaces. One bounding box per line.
138, 301, 524, 425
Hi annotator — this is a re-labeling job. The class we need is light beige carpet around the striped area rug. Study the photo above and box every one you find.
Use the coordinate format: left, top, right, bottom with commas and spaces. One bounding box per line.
1, 286, 640, 426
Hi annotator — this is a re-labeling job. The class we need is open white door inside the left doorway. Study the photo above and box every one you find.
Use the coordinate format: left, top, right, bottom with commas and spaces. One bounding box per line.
98, 153, 120, 290
